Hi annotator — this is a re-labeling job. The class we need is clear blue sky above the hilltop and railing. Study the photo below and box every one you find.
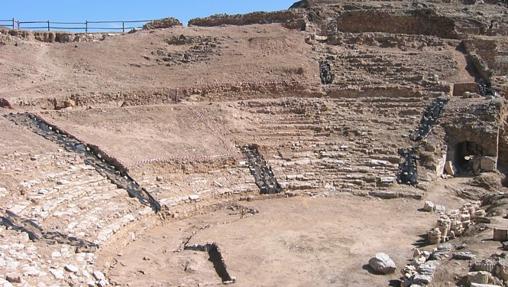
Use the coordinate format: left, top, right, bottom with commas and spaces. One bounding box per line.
0, 0, 296, 30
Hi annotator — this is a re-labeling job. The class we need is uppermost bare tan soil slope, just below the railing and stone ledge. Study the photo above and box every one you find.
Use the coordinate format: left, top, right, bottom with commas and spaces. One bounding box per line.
0, 24, 319, 103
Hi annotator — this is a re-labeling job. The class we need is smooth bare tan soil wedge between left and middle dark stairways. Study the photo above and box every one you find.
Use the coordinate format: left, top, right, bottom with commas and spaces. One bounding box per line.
45, 104, 240, 168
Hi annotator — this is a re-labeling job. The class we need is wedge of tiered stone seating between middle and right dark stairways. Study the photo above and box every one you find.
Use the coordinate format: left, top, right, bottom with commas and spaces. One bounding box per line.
231, 92, 437, 194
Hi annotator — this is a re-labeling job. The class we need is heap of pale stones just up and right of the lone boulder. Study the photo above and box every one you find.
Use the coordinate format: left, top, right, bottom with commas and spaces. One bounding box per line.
427, 202, 486, 244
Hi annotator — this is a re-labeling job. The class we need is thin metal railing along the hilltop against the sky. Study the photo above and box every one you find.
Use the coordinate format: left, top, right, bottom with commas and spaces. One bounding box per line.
0, 19, 153, 33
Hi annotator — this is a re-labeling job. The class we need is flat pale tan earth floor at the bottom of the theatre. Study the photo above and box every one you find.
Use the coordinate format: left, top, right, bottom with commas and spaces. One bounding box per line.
99, 196, 436, 286
